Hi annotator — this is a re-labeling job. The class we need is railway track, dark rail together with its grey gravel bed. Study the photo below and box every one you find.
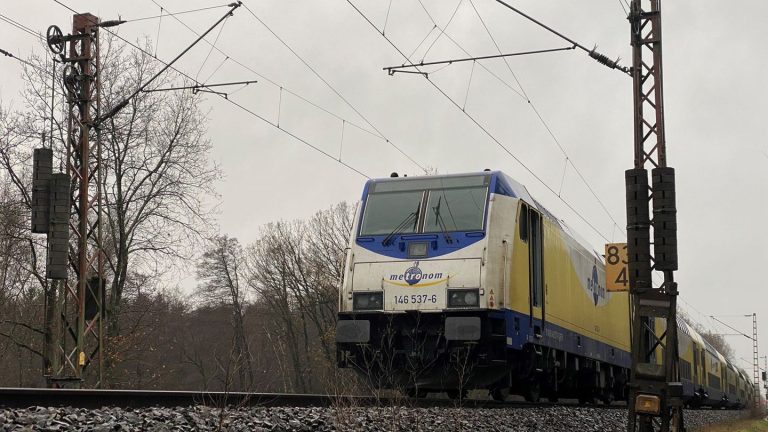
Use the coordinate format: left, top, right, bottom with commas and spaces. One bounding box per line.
0, 388, 743, 432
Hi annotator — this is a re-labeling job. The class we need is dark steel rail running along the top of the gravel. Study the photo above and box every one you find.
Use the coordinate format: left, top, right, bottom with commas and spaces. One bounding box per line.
0, 388, 626, 409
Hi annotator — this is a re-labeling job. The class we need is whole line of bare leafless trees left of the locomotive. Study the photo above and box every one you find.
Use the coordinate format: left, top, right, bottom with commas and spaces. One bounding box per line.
0, 34, 362, 392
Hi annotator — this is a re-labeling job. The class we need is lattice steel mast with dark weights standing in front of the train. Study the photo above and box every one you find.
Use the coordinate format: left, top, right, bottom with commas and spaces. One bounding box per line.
626, 0, 685, 432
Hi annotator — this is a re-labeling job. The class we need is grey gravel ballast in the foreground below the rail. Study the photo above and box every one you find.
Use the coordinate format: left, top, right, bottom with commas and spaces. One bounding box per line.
0, 406, 744, 432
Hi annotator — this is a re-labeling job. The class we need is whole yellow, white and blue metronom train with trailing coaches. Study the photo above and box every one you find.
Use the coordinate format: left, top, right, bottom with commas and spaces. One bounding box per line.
336, 171, 749, 406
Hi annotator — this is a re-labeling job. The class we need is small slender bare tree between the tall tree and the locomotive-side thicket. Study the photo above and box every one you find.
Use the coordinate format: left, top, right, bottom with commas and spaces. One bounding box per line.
195, 235, 253, 389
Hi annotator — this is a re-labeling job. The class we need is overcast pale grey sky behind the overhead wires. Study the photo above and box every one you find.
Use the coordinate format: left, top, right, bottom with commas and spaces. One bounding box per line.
0, 0, 768, 374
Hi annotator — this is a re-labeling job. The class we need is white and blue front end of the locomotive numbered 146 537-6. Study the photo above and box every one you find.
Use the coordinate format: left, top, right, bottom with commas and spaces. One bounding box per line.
336, 173, 503, 391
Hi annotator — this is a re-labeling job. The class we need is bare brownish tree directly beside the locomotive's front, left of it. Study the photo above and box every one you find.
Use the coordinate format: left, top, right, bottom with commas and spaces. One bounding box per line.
247, 203, 353, 391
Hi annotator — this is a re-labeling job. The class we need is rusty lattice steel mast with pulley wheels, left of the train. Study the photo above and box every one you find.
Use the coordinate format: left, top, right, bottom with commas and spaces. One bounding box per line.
41, 14, 105, 387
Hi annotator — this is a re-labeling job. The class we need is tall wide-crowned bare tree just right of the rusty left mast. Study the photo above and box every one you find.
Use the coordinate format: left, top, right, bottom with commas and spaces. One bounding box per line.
101, 39, 220, 335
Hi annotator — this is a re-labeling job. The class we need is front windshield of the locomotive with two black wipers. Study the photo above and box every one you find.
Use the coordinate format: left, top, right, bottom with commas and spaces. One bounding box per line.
360, 175, 490, 236
